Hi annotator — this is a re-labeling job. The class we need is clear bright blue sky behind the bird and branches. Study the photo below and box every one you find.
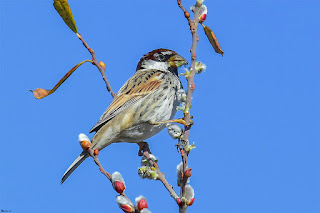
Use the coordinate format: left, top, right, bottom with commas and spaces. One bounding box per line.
0, 0, 320, 213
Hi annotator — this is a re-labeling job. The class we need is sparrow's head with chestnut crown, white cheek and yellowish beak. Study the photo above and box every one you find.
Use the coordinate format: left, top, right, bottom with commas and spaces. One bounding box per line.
137, 49, 188, 75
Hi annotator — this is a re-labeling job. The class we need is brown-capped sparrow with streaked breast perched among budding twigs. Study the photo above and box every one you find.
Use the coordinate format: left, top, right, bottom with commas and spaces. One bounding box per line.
61, 49, 187, 183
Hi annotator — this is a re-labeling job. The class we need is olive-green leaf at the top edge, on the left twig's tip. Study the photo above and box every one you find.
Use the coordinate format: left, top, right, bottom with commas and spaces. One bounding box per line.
53, 0, 78, 33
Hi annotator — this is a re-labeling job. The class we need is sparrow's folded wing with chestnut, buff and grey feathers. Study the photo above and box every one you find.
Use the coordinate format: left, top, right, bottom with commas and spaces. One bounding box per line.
90, 70, 164, 133
